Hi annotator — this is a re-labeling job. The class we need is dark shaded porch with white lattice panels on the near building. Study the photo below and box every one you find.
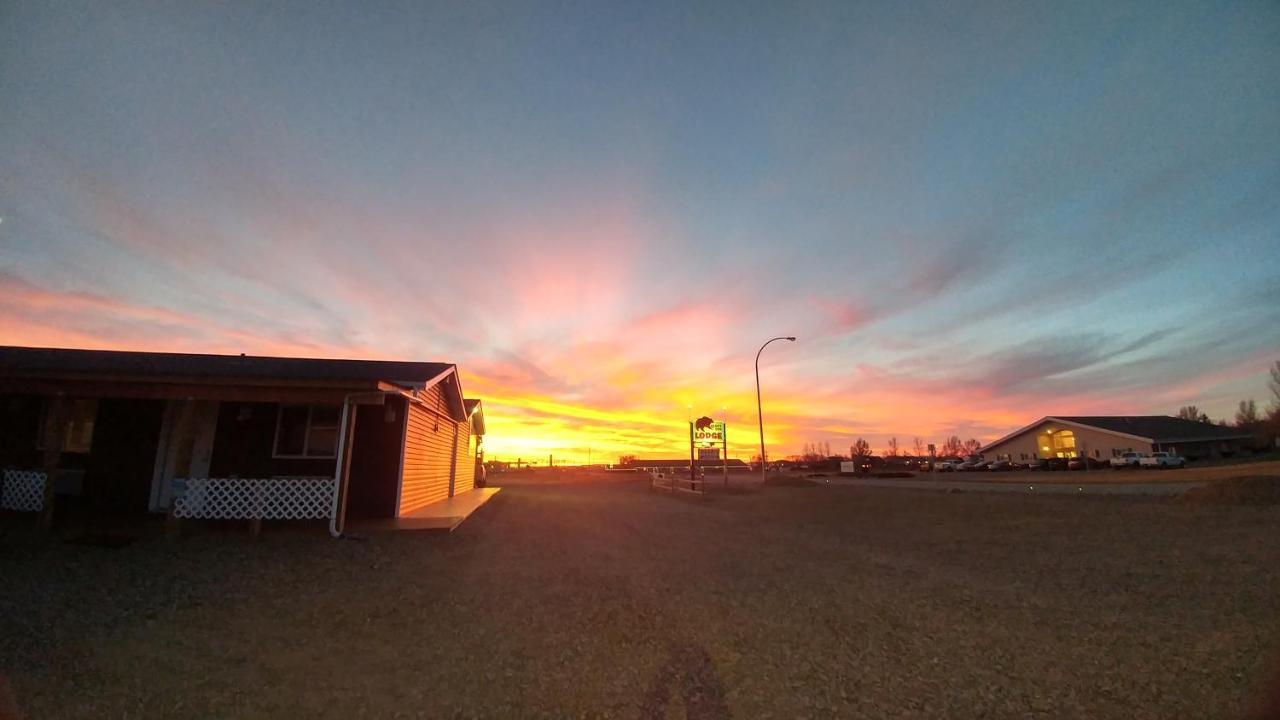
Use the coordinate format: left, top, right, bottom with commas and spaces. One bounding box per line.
0, 378, 403, 533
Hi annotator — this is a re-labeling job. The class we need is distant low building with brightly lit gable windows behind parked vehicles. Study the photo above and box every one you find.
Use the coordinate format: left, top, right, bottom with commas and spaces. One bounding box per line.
980, 415, 1253, 461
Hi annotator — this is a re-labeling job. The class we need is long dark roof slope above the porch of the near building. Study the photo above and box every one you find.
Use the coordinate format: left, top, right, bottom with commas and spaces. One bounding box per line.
0, 346, 453, 383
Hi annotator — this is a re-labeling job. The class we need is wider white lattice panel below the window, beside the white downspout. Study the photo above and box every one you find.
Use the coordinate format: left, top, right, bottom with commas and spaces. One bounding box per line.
173, 478, 334, 520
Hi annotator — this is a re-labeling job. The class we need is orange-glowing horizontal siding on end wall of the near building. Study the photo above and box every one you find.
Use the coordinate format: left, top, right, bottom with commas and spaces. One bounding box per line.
399, 384, 461, 515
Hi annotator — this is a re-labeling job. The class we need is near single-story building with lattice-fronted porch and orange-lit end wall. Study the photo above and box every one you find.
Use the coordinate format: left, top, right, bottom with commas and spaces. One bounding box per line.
0, 346, 484, 534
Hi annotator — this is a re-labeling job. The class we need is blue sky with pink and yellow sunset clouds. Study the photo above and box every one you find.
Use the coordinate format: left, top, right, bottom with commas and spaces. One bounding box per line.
0, 0, 1280, 461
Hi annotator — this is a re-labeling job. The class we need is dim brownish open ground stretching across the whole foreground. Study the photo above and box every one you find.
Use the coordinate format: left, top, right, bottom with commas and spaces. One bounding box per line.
0, 473, 1280, 720
